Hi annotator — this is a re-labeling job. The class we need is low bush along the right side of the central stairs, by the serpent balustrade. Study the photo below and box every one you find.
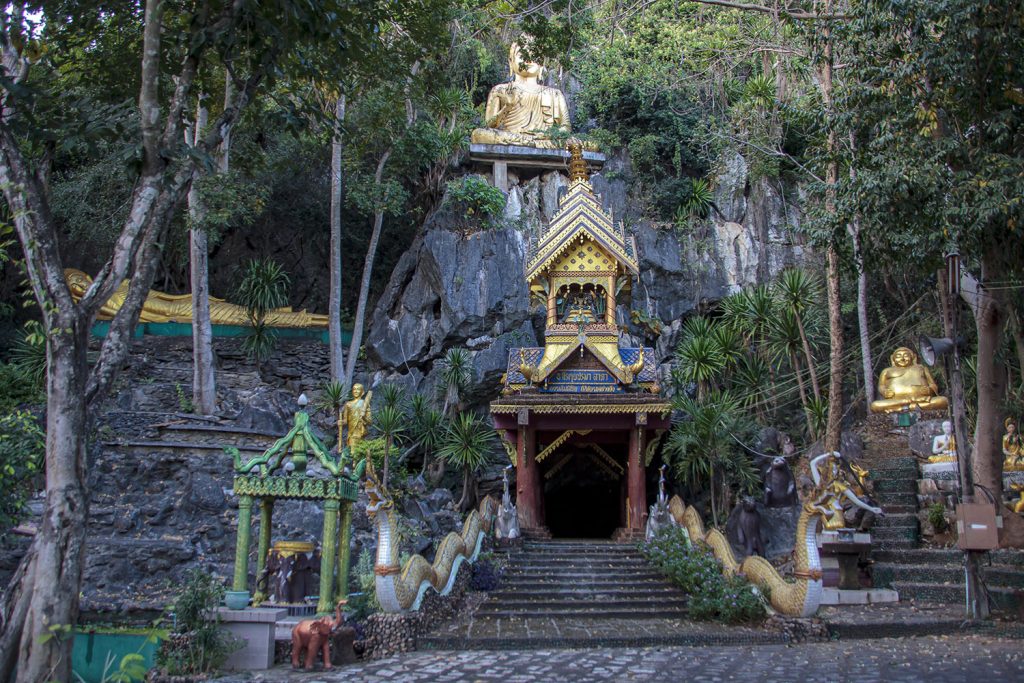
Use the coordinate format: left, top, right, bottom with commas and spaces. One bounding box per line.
640, 526, 766, 624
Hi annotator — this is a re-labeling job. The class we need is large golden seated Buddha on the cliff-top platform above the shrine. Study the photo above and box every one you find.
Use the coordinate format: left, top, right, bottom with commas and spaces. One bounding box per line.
470, 43, 569, 148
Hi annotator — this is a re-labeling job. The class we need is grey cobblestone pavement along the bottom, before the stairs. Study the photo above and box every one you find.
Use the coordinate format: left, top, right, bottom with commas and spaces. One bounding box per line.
222, 636, 1024, 683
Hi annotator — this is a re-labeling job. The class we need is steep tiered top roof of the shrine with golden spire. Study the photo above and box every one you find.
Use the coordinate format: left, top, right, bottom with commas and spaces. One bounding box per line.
526, 145, 640, 283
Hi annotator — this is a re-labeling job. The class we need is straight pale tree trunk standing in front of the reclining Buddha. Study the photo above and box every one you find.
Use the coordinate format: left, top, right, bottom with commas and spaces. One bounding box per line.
185, 93, 217, 415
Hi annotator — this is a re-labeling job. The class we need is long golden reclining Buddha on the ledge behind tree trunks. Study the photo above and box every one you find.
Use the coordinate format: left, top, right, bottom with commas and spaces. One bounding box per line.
65, 268, 327, 328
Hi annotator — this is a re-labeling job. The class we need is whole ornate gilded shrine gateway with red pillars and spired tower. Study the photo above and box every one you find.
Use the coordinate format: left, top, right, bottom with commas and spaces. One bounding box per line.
490, 140, 671, 538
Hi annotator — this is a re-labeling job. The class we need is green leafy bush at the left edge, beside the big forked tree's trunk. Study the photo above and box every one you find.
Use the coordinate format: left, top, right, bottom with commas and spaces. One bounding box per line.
0, 410, 46, 538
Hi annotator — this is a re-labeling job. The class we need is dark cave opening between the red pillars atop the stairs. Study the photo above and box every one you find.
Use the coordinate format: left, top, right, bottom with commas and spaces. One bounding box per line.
544, 447, 625, 539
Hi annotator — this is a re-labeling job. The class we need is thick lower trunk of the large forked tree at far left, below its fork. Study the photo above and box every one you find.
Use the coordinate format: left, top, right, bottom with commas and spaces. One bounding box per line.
17, 311, 91, 681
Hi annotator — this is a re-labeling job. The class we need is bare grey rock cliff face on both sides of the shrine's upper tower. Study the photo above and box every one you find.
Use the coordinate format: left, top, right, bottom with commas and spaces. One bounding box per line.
366, 149, 811, 403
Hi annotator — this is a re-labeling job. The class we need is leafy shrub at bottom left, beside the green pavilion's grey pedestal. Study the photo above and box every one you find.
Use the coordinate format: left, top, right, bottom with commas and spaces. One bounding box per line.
157, 569, 241, 676
